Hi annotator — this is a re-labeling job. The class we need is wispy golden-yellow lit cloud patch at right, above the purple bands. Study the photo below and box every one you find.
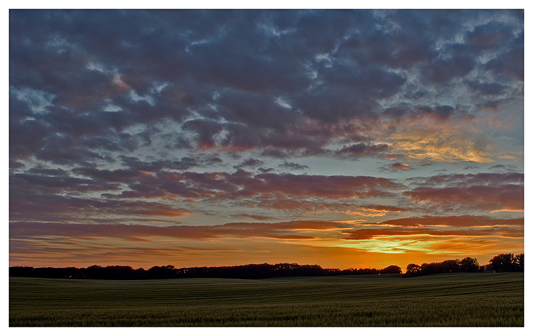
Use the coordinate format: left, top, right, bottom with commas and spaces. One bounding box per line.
372, 98, 520, 163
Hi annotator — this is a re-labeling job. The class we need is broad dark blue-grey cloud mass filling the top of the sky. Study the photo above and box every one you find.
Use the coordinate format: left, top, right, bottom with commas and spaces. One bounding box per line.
10, 10, 523, 158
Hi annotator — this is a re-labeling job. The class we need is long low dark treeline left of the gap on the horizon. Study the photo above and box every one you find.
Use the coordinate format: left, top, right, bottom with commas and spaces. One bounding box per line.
9, 264, 401, 280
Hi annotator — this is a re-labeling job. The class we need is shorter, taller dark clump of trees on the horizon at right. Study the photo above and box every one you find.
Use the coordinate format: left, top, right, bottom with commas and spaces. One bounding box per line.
404, 253, 524, 276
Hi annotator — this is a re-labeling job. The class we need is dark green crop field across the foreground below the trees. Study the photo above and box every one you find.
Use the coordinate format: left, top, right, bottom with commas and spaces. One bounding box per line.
9, 273, 524, 327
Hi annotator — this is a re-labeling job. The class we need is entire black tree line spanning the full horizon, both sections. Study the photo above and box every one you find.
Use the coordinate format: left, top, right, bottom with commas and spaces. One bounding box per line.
9, 253, 524, 280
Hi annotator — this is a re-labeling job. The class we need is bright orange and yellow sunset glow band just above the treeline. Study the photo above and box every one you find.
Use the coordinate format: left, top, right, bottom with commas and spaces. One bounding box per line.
10, 229, 524, 270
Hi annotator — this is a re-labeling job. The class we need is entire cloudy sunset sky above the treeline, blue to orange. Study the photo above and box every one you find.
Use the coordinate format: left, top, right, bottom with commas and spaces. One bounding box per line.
9, 10, 524, 270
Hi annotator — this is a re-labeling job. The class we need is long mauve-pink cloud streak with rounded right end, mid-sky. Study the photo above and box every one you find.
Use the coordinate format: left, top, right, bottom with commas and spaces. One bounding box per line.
76, 169, 400, 199
